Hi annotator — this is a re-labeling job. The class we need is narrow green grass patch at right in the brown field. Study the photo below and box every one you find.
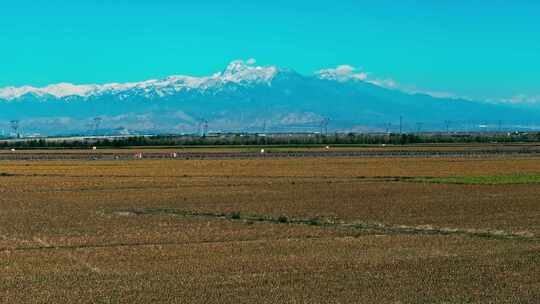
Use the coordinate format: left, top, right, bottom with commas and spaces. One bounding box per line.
412, 175, 540, 185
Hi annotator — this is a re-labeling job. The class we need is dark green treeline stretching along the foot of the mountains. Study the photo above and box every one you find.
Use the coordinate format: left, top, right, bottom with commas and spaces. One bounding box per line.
0, 133, 540, 149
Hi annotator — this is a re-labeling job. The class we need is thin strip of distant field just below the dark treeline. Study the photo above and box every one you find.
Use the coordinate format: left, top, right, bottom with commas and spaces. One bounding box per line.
0, 143, 540, 161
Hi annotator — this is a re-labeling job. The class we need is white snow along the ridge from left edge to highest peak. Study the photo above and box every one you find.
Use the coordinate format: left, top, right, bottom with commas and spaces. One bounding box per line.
0, 59, 279, 100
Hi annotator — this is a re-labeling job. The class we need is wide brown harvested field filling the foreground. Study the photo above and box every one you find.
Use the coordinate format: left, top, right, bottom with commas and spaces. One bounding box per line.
0, 155, 540, 303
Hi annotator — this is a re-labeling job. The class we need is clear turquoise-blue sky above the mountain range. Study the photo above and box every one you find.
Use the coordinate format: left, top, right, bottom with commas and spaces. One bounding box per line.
0, 0, 540, 97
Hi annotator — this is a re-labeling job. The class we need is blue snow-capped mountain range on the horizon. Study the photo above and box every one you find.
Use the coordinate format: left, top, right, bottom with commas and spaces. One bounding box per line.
0, 60, 540, 134
